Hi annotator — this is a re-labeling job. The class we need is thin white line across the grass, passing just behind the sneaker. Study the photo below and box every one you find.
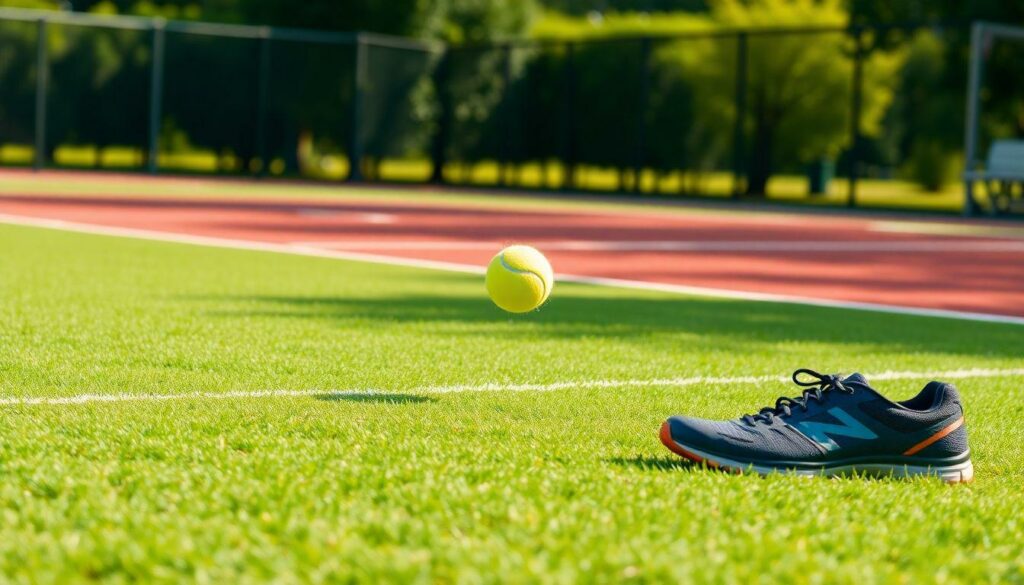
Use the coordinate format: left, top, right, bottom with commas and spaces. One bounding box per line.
6, 368, 1024, 406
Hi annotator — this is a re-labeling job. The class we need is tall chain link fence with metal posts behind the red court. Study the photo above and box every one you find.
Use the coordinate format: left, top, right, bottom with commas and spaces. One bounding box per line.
0, 9, 1024, 211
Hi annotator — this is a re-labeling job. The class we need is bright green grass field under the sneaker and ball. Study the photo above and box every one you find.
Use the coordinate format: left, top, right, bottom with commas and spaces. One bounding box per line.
0, 225, 1024, 583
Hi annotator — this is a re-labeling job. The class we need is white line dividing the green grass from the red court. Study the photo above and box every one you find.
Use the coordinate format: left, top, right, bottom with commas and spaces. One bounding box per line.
0, 213, 1024, 325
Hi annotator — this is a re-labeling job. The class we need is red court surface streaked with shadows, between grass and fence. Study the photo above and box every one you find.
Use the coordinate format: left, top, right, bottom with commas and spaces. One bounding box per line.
0, 196, 1024, 323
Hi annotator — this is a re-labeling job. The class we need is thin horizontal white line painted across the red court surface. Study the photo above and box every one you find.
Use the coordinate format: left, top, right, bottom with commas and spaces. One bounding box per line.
290, 240, 1024, 254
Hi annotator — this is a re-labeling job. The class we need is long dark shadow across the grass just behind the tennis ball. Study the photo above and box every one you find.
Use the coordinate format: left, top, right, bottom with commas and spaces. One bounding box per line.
187, 286, 1024, 358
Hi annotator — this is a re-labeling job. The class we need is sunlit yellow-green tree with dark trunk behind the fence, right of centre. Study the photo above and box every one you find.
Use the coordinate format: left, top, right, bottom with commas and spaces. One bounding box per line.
696, 0, 899, 195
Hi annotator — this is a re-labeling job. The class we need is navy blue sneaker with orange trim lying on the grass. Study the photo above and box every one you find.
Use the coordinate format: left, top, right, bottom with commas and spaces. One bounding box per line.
662, 370, 974, 484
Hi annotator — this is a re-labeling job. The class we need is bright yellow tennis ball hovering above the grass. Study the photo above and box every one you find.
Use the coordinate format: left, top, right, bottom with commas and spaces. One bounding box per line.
486, 246, 555, 312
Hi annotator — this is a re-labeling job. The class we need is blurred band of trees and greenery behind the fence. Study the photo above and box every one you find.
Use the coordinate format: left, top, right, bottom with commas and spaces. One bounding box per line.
0, 0, 1024, 211
